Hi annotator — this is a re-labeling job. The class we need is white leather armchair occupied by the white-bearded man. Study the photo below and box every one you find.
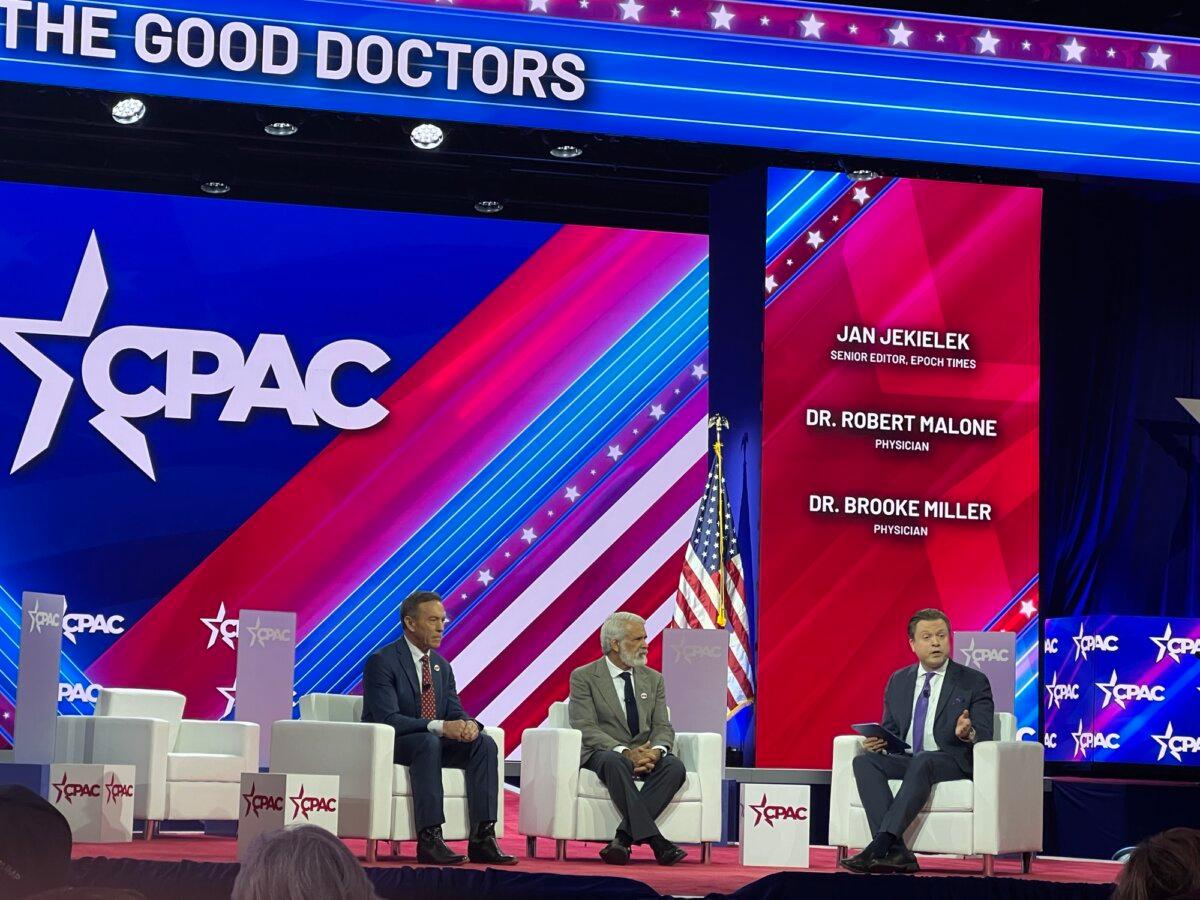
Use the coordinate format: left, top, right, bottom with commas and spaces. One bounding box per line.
518, 703, 724, 862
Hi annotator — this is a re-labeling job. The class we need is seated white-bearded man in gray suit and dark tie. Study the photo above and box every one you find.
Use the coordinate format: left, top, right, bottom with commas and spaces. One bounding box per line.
568, 612, 688, 865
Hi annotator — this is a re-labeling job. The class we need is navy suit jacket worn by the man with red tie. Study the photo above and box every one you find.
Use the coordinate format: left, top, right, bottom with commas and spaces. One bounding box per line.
362, 637, 470, 736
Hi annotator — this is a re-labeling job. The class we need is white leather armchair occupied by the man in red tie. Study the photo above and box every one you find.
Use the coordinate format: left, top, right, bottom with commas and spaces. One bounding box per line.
271, 694, 504, 862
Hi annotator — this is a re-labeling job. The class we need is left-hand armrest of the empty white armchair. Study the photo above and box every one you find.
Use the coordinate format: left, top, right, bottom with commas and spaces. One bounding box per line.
55, 715, 170, 821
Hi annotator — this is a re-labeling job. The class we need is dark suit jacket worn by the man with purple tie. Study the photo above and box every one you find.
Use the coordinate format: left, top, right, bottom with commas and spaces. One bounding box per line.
881, 660, 996, 775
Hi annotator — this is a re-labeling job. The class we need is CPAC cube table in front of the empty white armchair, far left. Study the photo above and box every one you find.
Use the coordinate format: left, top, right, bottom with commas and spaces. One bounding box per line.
47, 762, 137, 844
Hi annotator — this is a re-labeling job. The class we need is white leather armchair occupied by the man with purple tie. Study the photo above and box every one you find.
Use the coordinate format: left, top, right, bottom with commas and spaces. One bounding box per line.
829, 713, 1045, 875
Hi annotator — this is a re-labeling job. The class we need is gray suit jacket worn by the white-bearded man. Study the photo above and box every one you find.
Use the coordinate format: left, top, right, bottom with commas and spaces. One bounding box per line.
566, 658, 674, 766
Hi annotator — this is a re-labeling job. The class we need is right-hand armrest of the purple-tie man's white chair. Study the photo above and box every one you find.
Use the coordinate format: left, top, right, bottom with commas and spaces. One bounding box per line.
973, 740, 1045, 853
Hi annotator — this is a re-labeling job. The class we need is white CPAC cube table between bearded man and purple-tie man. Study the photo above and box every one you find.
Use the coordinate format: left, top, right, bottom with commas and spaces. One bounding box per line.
739, 785, 812, 869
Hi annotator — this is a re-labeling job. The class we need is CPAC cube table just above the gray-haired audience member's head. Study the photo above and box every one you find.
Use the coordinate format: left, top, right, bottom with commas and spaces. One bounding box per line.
238, 772, 341, 859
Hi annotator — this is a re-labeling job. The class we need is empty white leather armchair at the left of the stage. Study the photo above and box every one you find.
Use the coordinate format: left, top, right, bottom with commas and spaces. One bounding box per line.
55, 688, 258, 840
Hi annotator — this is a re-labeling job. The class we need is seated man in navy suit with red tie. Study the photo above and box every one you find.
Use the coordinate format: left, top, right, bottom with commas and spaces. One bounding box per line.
362, 590, 517, 865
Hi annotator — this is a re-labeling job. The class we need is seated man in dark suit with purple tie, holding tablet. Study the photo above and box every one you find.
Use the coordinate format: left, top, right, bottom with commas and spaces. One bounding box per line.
841, 610, 996, 872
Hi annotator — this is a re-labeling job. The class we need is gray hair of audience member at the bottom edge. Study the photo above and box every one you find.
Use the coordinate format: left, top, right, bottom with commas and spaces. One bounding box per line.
232, 826, 377, 900
